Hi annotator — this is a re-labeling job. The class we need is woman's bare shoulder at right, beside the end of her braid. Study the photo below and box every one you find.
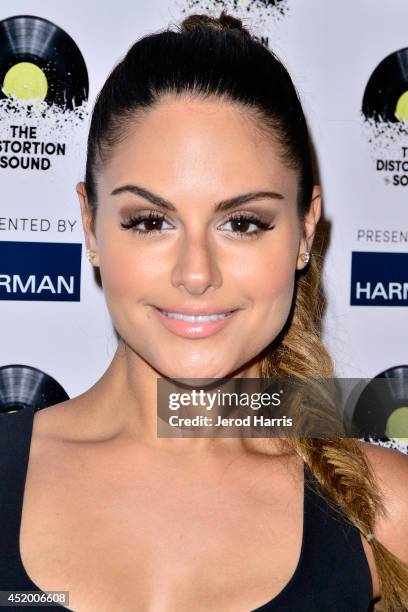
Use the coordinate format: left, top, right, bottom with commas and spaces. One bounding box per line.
358, 441, 408, 563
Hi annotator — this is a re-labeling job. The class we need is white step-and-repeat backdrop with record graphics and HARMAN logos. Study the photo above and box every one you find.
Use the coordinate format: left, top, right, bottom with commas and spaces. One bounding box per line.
0, 0, 408, 452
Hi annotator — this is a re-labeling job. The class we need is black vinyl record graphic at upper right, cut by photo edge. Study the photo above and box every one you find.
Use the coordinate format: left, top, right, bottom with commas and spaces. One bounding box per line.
362, 48, 408, 123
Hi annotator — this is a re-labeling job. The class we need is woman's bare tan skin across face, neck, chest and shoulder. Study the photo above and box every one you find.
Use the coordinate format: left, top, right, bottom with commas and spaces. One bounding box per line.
20, 96, 408, 612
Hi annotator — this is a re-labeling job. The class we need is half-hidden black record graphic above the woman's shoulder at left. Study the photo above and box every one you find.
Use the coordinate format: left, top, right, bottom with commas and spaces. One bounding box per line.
0, 365, 69, 412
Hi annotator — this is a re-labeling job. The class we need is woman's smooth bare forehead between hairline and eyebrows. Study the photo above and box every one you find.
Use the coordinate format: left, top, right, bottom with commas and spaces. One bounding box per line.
98, 98, 296, 196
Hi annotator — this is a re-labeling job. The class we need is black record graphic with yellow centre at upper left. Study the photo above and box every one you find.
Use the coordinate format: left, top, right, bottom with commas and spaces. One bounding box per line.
0, 15, 89, 109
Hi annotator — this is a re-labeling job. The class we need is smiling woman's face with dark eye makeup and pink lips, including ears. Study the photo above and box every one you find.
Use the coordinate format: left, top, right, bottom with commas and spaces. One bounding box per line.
78, 96, 320, 378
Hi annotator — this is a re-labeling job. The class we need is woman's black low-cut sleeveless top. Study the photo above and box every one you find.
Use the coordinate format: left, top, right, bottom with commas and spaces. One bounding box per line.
0, 408, 372, 612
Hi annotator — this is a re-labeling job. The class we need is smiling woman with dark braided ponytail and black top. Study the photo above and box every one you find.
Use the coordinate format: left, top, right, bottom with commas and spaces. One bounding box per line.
0, 13, 408, 612
